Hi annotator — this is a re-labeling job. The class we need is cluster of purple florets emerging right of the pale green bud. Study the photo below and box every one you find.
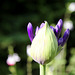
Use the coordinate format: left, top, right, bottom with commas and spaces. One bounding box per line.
50, 19, 70, 46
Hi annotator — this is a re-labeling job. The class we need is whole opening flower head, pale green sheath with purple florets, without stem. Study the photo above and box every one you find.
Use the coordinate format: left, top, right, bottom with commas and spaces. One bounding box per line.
27, 19, 70, 65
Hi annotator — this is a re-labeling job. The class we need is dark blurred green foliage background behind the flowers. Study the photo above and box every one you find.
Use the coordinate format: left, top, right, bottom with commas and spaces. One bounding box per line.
0, 0, 75, 75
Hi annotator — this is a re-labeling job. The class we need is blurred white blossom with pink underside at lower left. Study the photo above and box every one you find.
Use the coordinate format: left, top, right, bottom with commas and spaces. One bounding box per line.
6, 53, 21, 66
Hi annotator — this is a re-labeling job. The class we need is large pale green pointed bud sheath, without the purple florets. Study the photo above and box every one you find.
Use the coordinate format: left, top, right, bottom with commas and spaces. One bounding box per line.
30, 21, 58, 65
